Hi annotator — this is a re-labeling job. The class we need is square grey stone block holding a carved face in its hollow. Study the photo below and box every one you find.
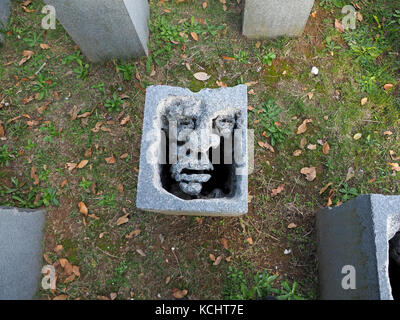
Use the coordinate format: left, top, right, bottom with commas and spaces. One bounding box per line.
136, 85, 248, 216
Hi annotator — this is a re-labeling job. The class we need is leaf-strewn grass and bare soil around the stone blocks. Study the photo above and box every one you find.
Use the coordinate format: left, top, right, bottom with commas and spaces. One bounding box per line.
0, 0, 400, 299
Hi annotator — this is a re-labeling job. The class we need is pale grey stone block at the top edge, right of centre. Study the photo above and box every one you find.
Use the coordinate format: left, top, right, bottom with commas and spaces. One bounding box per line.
243, 0, 314, 39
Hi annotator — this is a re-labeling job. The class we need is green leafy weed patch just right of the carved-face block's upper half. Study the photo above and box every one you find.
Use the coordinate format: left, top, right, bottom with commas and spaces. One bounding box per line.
258, 99, 290, 146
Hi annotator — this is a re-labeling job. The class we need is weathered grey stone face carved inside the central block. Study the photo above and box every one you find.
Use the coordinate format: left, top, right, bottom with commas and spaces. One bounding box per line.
163, 97, 238, 198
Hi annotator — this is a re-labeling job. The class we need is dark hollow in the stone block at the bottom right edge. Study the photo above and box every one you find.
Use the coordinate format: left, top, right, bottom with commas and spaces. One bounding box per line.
389, 231, 400, 301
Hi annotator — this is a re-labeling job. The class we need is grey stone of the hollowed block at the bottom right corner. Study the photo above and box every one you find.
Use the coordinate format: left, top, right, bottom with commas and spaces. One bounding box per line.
317, 194, 400, 300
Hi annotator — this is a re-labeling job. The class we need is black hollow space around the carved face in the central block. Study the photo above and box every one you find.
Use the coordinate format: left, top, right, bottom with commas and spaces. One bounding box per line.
160, 131, 236, 200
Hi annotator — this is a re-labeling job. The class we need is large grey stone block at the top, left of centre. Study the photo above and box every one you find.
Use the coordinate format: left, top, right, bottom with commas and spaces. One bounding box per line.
45, 0, 150, 62
